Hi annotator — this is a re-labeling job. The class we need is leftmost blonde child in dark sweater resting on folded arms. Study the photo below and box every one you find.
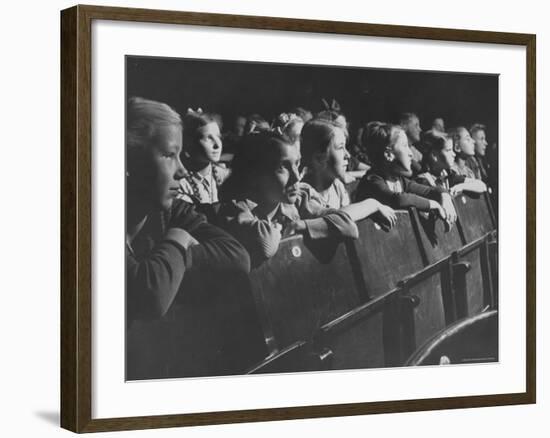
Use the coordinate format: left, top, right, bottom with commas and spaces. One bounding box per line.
126, 97, 250, 324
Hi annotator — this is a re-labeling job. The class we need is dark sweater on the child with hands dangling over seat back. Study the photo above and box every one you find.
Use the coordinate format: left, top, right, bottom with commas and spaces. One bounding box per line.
355, 168, 445, 211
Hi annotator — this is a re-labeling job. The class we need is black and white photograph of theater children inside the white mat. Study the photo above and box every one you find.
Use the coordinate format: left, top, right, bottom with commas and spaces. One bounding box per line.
127, 55, 499, 380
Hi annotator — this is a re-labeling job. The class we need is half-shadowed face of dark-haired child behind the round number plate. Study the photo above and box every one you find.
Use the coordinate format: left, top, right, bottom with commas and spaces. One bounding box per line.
258, 143, 300, 204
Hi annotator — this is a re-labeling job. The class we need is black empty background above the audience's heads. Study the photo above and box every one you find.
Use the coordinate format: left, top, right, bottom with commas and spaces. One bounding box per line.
126, 56, 498, 145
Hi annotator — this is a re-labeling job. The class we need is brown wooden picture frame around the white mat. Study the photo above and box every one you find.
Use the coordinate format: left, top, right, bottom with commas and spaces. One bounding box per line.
61, 6, 536, 433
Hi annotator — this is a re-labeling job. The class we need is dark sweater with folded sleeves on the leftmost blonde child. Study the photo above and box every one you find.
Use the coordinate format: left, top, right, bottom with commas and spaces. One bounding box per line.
126, 200, 250, 323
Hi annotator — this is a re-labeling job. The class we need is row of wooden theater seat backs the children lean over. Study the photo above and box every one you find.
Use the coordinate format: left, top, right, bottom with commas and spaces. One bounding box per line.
249, 195, 498, 373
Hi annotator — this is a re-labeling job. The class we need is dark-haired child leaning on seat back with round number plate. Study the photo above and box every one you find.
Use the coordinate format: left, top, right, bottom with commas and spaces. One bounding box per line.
219, 131, 364, 266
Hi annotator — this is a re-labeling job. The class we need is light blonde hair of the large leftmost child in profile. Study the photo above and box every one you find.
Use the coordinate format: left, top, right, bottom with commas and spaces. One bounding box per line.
126, 97, 182, 152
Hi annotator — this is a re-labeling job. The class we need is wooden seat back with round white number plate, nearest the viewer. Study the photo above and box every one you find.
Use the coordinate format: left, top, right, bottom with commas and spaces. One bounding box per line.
250, 235, 360, 353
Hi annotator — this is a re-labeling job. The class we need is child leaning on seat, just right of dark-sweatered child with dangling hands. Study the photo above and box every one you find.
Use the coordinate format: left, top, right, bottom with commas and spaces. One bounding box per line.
416, 130, 487, 196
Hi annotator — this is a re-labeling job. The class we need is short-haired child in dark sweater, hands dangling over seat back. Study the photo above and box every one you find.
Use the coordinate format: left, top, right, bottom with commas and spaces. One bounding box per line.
356, 122, 456, 227
